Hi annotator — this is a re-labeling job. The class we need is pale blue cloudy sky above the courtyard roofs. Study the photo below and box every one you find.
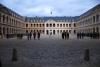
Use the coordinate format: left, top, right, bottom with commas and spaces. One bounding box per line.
0, 0, 100, 16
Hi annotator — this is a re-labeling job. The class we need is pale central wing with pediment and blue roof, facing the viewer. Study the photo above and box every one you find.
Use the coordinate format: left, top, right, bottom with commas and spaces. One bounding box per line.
25, 16, 78, 35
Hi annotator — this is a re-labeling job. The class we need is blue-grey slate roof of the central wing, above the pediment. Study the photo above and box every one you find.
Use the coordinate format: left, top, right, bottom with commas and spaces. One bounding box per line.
25, 16, 78, 22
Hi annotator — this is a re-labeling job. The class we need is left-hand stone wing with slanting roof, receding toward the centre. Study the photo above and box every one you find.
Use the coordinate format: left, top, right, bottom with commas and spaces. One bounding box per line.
0, 4, 25, 37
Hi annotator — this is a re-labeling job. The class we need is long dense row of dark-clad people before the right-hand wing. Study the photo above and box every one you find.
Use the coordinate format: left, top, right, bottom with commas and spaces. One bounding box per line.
77, 32, 100, 39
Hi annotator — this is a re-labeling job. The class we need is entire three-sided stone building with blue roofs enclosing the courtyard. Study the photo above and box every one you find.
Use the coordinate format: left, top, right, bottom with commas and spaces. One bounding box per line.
0, 4, 100, 38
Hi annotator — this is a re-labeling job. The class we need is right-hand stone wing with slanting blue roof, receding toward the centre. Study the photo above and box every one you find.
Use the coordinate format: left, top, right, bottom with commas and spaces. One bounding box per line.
76, 4, 100, 33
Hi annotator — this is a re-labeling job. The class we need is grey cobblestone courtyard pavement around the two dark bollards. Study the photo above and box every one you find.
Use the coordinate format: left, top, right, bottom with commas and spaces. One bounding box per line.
0, 37, 100, 67
